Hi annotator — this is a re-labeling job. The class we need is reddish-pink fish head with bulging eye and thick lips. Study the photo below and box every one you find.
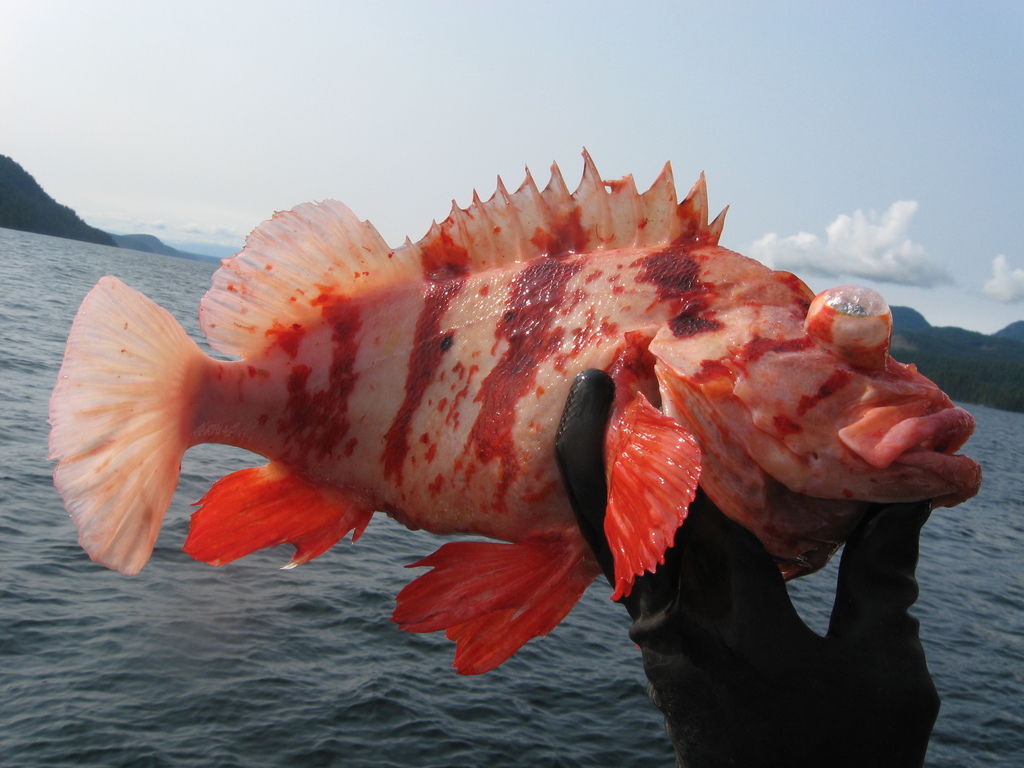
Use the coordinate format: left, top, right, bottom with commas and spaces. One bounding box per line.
650, 272, 981, 569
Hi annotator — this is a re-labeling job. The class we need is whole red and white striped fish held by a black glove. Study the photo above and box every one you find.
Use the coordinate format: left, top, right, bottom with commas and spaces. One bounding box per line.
49, 151, 981, 674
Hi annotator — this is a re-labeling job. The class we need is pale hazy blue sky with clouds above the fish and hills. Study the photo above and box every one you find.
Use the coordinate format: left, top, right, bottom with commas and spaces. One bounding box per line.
0, 0, 1024, 333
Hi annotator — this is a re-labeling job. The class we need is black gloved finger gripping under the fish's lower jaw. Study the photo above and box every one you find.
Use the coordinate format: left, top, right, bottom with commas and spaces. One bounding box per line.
828, 500, 931, 645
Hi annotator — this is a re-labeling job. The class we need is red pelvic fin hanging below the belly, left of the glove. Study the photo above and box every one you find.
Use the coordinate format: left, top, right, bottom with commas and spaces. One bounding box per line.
392, 537, 599, 675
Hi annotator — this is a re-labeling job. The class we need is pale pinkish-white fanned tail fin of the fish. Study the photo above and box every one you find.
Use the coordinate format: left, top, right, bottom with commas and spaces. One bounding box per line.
49, 276, 205, 574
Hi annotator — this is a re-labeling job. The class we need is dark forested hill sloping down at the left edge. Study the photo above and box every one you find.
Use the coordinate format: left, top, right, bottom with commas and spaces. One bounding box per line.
0, 155, 116, 246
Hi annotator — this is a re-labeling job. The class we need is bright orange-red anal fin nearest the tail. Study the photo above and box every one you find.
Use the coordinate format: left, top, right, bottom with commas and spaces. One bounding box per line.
184, 463, 373, 567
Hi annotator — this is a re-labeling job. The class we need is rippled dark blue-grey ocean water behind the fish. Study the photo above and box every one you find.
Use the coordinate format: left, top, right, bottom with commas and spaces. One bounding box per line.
0, 229, 1024, 768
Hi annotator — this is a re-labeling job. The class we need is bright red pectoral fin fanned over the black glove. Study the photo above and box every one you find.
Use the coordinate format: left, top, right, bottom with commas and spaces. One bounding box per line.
604, 394, 700, 600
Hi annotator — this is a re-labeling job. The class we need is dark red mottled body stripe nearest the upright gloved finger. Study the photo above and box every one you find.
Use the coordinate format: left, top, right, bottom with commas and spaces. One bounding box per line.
467, 259, 583, 508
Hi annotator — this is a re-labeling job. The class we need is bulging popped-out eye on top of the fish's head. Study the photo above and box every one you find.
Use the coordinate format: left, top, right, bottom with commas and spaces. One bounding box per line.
804, 286, 893, 370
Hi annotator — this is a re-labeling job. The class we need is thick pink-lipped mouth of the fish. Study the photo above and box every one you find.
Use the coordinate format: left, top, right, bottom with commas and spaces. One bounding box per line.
839, 407, 981, 507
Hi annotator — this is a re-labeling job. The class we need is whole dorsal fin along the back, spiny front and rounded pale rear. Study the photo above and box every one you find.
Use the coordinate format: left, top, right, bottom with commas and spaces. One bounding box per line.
200, 151, 725, 355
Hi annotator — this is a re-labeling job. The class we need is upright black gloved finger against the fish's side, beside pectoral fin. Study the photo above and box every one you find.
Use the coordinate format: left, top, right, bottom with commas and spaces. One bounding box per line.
555, 369, 615, 583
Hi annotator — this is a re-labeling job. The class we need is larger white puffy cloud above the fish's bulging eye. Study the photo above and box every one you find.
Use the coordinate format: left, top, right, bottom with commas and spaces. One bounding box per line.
751, 200, 951, 287
